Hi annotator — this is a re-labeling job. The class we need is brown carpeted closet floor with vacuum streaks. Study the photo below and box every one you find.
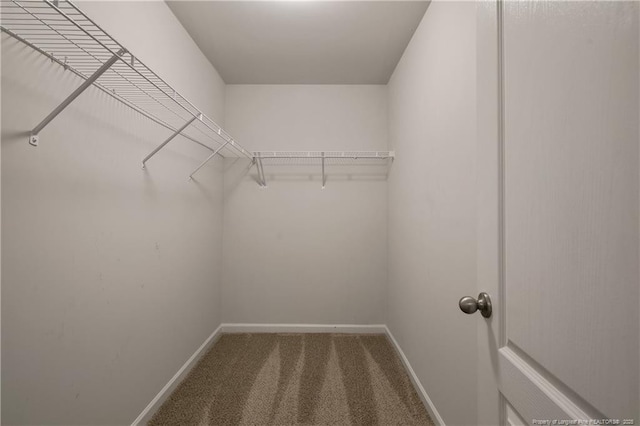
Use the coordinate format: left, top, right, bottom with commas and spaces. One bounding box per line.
149, 334, 433, 426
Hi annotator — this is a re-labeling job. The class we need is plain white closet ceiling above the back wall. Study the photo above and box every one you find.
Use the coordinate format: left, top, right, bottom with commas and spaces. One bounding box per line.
167, 1, 428, 84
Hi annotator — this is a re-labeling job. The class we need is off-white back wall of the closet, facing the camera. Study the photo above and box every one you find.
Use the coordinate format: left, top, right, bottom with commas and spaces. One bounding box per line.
222, 85, 387, 324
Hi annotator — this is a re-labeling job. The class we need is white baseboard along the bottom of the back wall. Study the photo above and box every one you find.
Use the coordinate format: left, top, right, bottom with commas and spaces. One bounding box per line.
220, 324, 387, 334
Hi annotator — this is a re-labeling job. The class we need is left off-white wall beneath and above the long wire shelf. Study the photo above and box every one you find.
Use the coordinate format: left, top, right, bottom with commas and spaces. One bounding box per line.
2, 2, 224, 425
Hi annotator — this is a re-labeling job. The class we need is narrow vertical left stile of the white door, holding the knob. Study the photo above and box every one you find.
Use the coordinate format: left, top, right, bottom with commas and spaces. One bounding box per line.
476, 0, 507, 425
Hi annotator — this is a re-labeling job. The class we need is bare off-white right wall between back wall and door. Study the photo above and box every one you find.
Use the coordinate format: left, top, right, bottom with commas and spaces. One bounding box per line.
388, 1, 477, 425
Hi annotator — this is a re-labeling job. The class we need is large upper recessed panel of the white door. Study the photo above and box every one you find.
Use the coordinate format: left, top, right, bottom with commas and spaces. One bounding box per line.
503, 1, 640, 420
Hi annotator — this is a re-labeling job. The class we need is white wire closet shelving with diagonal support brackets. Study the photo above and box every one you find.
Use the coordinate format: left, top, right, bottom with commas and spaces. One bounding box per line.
0, 0, 393, 187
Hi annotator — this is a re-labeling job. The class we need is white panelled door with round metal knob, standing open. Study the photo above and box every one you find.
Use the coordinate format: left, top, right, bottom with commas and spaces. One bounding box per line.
469, 0, 640, 424
